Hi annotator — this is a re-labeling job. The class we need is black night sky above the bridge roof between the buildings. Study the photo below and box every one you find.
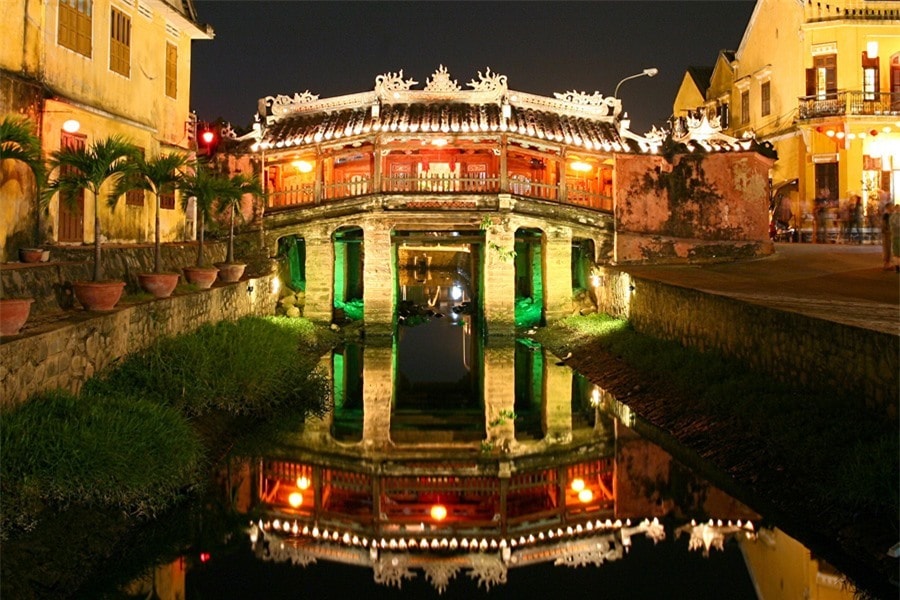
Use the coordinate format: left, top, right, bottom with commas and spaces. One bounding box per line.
191, 0, 754, 133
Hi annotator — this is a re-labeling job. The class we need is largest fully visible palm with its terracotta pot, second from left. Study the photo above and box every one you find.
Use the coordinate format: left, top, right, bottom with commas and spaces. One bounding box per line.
44, 135, 139, 310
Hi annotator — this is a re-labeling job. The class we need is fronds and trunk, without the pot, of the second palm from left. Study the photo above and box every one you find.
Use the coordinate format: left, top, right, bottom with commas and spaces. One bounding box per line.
44, 135, 139, 282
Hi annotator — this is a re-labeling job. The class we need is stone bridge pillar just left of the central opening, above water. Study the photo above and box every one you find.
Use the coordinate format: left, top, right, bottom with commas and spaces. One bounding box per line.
363, 220, 396, 335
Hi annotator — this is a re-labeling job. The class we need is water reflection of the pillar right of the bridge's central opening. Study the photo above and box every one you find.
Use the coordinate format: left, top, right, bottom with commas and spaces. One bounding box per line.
484, 344, 516, 450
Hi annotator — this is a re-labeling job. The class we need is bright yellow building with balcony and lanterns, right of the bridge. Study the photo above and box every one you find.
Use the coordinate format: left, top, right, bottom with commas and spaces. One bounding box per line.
674, 0, 900, 241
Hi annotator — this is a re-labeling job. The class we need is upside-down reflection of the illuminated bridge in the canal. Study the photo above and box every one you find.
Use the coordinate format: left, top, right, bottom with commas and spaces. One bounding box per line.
232, 344, 758, 589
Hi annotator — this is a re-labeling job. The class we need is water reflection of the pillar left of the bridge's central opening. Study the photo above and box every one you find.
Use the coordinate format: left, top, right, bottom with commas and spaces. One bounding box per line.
363, 344, 394, 448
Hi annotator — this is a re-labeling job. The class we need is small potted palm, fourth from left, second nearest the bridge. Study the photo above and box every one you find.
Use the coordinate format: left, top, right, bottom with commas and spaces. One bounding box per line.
178, 161, 234, 288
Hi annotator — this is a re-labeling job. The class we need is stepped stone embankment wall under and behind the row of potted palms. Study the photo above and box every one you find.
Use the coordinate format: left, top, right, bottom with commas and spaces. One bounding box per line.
0, 243, 278, 408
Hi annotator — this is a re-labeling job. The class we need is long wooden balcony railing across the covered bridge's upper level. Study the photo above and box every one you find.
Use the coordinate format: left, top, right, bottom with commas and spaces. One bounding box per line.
268, 173, 612, 211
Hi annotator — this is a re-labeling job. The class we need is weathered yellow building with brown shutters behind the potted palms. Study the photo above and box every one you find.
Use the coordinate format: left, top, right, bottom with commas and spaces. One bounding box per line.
0, 0, 213, 260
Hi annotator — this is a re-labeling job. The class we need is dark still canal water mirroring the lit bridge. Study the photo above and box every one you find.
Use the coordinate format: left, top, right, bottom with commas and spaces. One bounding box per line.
3, 286, 852, 600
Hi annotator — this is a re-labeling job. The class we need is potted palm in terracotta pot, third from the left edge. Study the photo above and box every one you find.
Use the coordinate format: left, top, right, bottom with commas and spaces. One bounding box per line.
115, 152, 187, 298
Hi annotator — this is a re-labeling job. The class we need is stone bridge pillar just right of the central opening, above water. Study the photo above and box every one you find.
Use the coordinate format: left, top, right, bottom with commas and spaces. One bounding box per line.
482, 224, 516, 336
